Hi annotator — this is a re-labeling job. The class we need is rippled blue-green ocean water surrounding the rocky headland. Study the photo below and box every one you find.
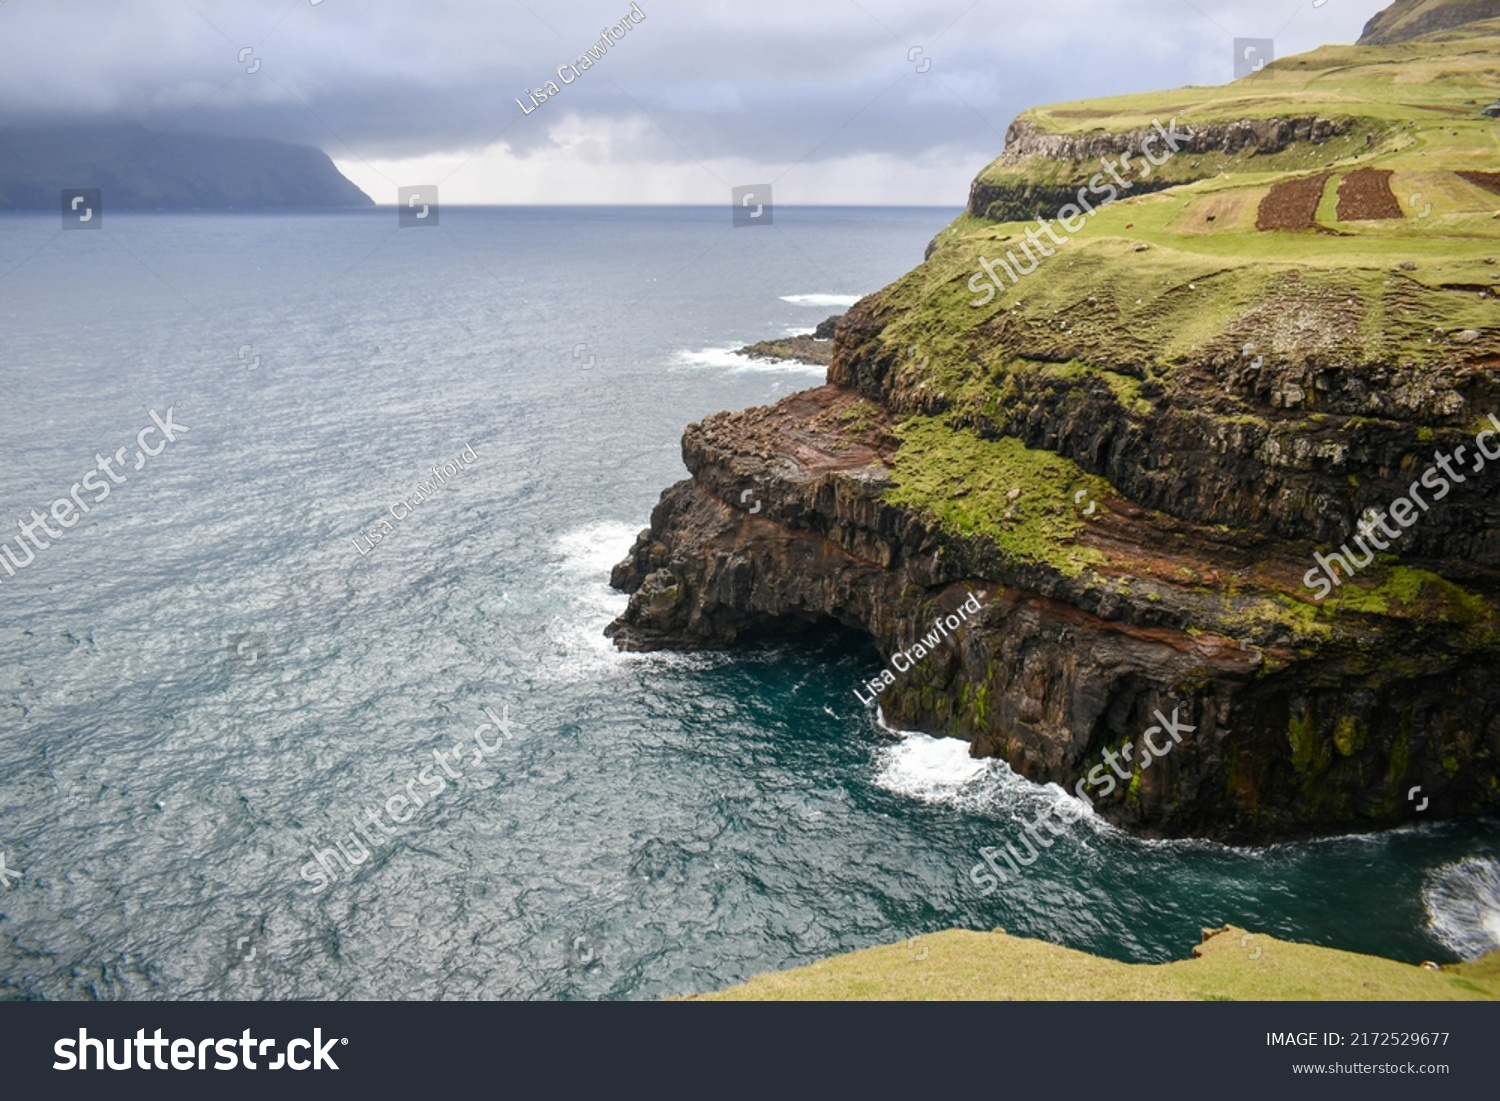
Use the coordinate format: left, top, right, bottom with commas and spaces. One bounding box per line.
0, 209, 1500, 999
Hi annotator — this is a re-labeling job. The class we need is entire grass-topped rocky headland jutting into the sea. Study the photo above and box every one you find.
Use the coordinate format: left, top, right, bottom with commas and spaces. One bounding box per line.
609, 8, 1500, 842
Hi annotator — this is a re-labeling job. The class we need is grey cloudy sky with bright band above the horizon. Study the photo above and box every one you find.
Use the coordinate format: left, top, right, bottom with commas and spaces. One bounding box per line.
0, 0, 1386, 206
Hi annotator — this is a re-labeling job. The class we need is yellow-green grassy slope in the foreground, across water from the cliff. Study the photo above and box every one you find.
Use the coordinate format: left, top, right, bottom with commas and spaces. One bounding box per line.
707, 927, 1500, 1002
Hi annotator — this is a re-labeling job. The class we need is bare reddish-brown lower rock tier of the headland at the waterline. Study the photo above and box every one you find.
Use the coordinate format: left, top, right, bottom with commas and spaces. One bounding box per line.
609, 386, 1500, 842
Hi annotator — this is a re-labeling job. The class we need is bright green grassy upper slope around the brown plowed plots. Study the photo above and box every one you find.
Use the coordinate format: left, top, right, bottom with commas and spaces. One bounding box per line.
942, 21, 1500, 362
